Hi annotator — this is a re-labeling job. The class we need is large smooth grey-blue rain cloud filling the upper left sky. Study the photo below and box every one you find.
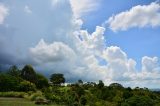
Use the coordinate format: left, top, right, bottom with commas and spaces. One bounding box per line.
0, 0, 72, 64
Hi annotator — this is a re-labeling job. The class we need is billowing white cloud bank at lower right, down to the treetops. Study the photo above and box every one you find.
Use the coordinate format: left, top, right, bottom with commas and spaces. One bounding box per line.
103, 46, 160, 87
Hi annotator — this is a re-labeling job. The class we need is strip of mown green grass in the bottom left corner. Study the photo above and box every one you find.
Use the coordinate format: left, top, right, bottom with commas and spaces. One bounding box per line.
0, 97, 58, 106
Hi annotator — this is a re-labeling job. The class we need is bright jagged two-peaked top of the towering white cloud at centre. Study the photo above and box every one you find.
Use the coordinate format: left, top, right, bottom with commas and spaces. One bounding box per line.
78, 26, 105, 54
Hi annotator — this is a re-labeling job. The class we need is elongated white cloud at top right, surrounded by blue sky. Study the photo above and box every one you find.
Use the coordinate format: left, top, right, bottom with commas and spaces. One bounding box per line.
105, 2, 160, 31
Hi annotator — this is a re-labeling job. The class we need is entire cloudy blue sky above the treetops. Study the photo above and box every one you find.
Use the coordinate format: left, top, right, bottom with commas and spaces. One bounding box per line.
0, 0, 160, 88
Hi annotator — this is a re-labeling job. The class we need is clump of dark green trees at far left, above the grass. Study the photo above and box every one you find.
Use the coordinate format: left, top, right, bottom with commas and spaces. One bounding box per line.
0, 65, 49, 92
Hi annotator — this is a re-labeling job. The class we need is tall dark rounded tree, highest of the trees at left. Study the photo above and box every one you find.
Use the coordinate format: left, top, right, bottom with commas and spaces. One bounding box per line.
21, 65, 36, 83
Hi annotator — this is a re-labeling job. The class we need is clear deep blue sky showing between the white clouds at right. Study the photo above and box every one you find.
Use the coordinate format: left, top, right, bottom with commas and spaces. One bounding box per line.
82, 0, 160, 68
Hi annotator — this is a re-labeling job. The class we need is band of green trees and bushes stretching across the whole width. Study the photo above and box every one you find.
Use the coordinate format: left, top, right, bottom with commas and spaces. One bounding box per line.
0, 65, 160, 106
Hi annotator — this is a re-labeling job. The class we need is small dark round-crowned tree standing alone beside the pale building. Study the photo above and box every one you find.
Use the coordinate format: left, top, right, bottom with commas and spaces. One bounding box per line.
50, 73, 65, 85
